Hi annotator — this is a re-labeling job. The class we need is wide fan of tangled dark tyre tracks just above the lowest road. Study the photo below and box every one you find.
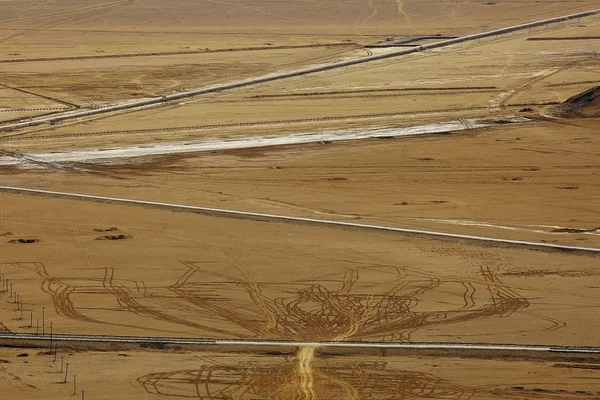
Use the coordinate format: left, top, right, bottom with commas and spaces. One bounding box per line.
0, 261, 564, 343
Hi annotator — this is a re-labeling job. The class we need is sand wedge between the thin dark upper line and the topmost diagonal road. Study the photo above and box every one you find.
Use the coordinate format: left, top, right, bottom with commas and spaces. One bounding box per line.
2, 45, 356, 106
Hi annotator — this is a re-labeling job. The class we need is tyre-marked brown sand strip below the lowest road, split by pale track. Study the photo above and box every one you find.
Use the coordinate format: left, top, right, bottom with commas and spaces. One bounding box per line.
0, 349, 600, 400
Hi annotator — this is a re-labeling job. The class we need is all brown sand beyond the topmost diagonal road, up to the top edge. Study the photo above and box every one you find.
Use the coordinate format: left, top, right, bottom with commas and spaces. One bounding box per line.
0, 0, 595, 113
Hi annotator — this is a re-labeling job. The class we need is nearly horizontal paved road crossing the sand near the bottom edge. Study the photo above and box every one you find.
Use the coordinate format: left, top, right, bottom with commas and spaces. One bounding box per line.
0, 333, 600, 354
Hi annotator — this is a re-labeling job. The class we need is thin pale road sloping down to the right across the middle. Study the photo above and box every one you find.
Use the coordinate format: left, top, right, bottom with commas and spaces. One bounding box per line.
0, 186, 600, 254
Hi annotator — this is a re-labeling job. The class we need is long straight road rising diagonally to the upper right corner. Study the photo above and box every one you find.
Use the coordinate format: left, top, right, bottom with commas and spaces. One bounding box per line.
0, 9, 600, 131
